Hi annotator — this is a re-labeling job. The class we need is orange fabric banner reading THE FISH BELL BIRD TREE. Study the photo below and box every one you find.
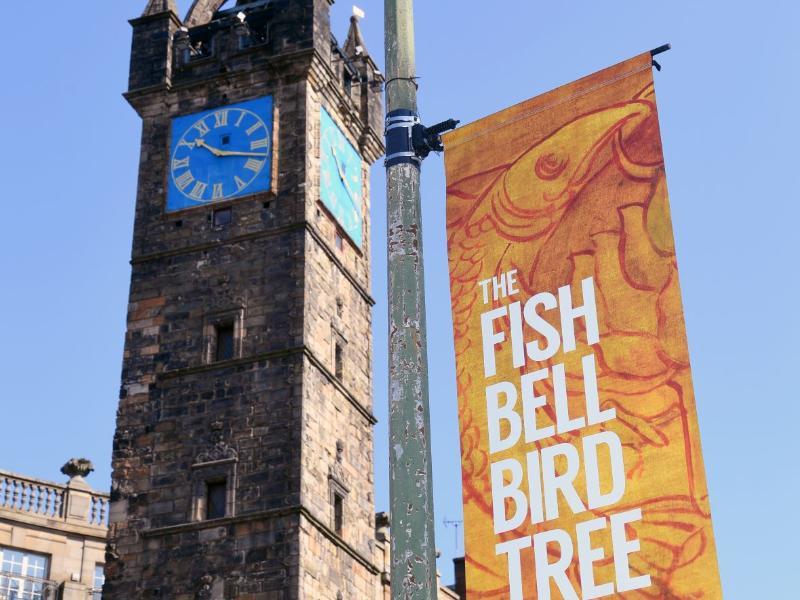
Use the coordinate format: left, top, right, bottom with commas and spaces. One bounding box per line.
445, 53, 722, 600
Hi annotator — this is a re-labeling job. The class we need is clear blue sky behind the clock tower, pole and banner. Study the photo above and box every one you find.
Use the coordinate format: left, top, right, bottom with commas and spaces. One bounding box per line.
0, 0, 800, 599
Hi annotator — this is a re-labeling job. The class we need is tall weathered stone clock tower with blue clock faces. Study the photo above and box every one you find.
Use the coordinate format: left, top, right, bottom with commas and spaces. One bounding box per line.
104, 0, 383, 600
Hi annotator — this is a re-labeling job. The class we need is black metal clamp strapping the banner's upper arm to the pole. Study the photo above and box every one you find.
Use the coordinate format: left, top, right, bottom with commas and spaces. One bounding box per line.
386, 110, 460, 167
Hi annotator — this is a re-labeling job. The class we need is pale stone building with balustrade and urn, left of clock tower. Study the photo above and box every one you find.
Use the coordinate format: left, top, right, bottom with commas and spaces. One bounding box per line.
0, 460, 108, 600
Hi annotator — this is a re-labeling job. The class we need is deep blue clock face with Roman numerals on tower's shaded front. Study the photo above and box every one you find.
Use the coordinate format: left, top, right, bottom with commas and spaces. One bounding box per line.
167, 96, 273, 212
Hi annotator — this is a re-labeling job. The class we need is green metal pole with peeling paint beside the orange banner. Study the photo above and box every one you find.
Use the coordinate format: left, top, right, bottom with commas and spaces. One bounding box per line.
385, 0, 438, 600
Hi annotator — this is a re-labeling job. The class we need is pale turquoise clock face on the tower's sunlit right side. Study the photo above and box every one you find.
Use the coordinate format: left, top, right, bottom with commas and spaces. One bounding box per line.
320, 108, 364, 247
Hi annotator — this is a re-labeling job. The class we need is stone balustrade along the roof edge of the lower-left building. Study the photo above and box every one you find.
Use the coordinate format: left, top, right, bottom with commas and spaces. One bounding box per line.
0, 470, 109, 528
